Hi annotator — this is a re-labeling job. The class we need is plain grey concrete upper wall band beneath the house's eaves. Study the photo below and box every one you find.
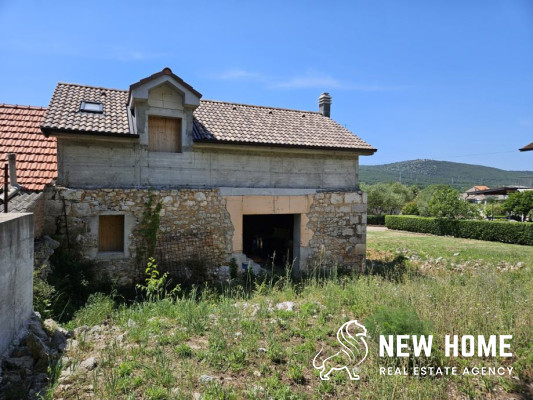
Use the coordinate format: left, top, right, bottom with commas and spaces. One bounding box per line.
58, 137, 358, 190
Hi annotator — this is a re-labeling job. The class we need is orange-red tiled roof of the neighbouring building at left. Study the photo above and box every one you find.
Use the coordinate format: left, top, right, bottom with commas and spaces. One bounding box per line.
0, 104, 57, 190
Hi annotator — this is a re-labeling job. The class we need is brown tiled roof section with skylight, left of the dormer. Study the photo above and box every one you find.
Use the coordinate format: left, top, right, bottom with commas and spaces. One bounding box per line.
42, 83, 130, 135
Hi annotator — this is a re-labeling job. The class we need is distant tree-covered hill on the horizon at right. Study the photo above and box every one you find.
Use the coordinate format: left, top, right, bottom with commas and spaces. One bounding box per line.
359, 160, 533, 190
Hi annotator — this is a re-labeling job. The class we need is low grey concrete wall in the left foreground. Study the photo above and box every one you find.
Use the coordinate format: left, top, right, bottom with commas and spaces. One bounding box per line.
0, 213, 34, 357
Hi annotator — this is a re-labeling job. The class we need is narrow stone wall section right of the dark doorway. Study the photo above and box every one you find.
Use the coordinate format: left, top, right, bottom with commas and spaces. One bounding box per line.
308, 192, 366, 271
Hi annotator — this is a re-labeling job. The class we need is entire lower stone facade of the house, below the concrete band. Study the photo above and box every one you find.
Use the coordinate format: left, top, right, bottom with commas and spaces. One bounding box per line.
45, 187, 366, 286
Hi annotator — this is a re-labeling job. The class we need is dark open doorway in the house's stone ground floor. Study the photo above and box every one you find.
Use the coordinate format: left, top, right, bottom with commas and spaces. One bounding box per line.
242, 214, 295, 268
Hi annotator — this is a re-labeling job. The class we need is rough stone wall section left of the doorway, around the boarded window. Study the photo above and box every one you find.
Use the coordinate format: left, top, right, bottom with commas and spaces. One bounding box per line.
44, 187, 233, 286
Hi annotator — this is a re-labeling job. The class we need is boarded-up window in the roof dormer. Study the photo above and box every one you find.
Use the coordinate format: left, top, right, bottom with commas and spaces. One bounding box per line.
148, 116, 181, 153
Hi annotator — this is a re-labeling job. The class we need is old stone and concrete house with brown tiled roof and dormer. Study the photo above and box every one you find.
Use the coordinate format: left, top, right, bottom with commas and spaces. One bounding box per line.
41, 68, 376, 284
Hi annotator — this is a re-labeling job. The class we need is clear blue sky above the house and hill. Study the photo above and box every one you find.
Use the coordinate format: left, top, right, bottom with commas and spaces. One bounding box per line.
0, 0, 533, 170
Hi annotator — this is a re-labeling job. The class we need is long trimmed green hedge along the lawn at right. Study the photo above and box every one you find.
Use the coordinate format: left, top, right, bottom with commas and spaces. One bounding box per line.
385, 215, 533, 246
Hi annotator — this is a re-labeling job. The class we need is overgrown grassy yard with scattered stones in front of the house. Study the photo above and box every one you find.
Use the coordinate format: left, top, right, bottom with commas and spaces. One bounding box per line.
50, 231, 533, 399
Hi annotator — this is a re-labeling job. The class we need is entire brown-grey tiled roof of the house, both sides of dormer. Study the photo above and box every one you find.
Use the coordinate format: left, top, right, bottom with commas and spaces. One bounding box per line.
42, 79, 376, 153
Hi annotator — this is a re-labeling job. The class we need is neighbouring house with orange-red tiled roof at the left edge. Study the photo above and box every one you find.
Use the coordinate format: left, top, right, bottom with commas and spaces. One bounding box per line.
0, 104, 57, 237
